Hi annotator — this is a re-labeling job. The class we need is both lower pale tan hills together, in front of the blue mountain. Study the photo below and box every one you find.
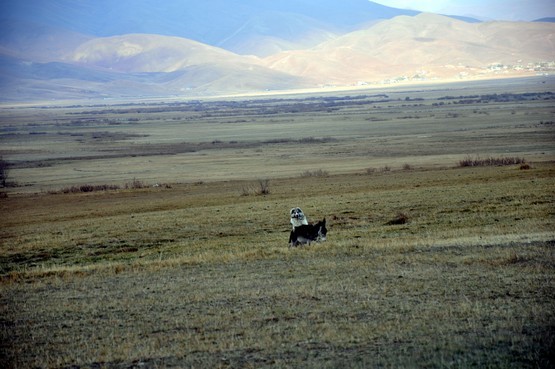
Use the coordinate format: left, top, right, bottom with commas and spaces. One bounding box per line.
0, 4, 555, 101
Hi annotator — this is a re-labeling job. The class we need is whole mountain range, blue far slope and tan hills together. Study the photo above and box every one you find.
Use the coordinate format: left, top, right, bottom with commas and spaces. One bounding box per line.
0, 0, 555, 101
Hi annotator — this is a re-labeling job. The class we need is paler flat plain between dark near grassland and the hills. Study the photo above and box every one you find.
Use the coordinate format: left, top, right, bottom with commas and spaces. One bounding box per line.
0, 77, 555, 192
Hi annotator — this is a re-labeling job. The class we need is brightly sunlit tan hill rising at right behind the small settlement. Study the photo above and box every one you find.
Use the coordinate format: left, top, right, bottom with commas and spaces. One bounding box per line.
265, 14, 555, 84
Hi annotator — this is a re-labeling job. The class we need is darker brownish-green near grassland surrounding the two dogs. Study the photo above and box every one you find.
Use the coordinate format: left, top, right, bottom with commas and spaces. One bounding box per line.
0, 163, 555, 368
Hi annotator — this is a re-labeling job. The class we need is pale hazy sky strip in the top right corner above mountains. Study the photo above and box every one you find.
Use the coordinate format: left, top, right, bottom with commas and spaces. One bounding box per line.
372, 0, 555, 21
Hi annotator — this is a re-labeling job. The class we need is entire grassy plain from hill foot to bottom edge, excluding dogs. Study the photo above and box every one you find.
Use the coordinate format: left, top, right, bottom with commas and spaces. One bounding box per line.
0, 79, 555, 368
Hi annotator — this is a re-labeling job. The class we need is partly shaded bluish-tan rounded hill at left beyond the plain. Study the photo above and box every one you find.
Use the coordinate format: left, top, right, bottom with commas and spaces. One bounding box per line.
0, 34, 308, 101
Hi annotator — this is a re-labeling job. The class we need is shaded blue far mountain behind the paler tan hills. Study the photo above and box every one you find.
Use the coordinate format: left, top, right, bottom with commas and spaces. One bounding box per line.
0, 0, 418, 56
